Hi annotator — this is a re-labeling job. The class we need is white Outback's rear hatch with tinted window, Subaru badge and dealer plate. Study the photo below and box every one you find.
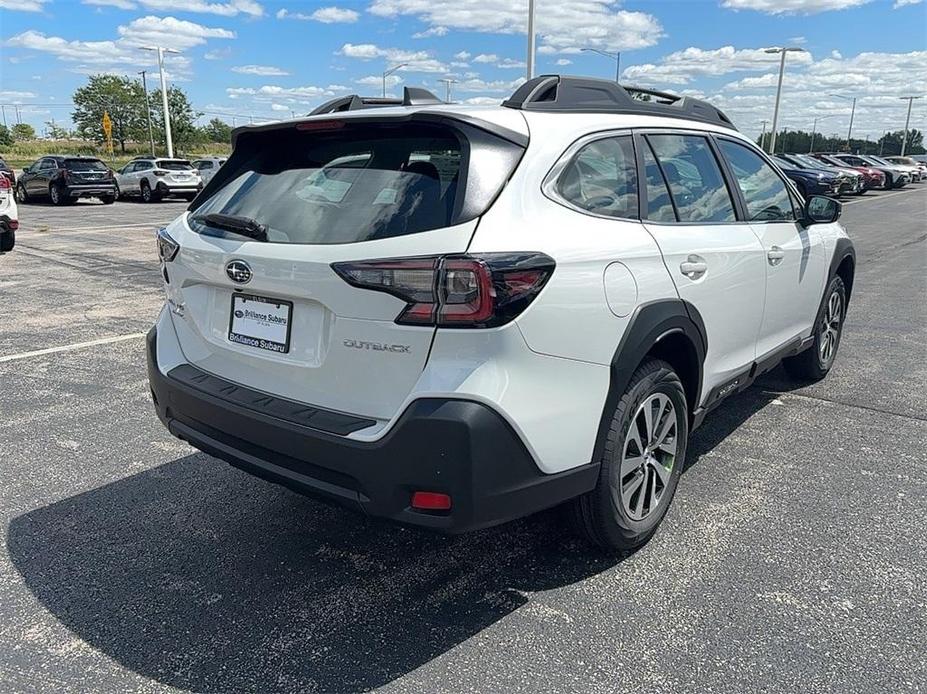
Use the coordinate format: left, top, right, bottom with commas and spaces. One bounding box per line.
166, 117, 523, 420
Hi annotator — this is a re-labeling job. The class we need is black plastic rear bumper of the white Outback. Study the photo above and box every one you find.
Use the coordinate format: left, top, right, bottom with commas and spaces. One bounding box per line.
147, 328, 598, 533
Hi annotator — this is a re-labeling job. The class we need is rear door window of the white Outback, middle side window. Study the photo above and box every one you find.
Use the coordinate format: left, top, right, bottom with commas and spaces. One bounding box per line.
647, 135, 736, 223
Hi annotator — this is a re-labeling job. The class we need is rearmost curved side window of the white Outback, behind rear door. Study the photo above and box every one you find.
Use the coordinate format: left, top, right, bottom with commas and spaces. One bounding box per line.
557, 135, 638, 219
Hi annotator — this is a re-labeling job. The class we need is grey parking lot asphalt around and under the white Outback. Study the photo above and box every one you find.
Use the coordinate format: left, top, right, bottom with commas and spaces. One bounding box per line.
0, 190, 927, 693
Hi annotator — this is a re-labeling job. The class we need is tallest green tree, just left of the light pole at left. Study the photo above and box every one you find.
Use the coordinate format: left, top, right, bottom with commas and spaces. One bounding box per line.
71, 75, 147, 154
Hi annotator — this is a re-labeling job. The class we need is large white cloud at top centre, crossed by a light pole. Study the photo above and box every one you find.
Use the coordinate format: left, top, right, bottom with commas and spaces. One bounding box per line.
369, 0, 663, 53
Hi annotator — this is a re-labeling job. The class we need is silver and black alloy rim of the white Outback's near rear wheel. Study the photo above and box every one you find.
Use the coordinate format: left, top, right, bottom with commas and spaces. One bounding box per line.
612, 393, 678, 520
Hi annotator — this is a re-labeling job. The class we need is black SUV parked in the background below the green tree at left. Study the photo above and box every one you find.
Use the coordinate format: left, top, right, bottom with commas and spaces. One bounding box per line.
16, 155, 116, 205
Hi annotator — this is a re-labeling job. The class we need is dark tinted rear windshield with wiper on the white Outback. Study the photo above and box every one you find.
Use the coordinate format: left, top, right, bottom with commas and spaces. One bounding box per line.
190, 122, 522, 244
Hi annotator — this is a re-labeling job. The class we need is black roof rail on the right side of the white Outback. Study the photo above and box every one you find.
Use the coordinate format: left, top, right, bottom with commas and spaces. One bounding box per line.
502, 75, 737, 130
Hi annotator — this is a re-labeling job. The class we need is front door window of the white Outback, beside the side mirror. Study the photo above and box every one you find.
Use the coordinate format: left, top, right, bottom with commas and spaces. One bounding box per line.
718, 140, 795, 222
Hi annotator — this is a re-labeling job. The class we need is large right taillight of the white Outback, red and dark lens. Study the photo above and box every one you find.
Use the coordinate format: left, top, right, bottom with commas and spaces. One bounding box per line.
332, 253, 554, 328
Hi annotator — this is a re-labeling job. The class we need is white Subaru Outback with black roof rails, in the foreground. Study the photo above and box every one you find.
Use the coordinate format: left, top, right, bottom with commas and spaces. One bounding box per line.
148, 75, 855, 549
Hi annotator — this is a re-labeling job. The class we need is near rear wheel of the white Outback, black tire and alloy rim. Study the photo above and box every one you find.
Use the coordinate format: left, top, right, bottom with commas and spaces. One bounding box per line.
572, 359, 689, 552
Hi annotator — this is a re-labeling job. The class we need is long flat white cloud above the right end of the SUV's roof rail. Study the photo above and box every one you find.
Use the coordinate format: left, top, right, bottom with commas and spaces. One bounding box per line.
622, 46, 811, 85
